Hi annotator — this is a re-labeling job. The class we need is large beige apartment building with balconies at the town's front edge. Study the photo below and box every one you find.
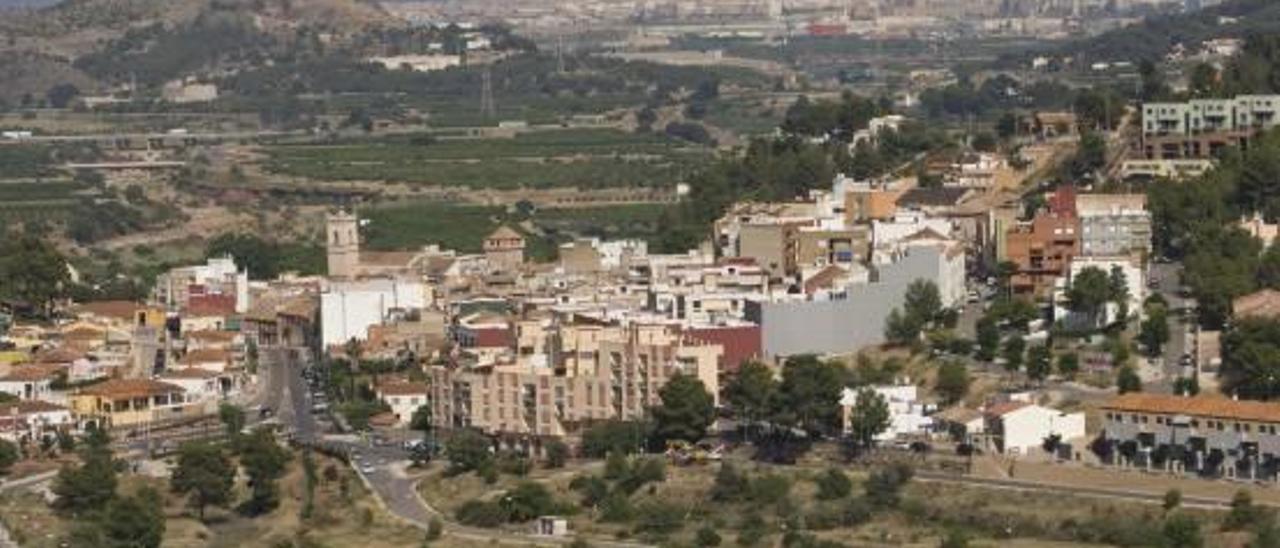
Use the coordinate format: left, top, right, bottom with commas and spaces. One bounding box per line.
429, 323, 723, 452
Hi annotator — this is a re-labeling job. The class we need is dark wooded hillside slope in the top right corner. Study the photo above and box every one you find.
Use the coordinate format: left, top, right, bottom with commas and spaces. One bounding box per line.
1001, 0, 1280, 63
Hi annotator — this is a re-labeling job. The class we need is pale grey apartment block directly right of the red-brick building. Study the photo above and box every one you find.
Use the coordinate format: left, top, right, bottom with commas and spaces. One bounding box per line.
1075, 195, 1151, 257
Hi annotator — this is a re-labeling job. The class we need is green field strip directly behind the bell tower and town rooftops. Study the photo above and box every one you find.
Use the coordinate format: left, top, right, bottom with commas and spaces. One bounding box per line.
361, 202, 668, 259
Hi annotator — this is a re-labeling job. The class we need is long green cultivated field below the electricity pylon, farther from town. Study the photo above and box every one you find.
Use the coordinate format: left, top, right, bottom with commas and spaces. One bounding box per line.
265, 131, 708, 188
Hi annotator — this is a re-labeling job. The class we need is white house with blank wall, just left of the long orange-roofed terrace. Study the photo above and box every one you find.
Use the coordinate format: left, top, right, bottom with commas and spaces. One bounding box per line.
983, 401, 1084, 455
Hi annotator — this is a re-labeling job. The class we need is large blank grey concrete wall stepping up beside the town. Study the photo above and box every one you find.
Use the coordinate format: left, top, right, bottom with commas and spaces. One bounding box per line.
745, 247, 943, 357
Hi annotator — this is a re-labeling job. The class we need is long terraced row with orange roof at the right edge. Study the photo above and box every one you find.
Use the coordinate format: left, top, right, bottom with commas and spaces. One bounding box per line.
1101, 392, 1280, 480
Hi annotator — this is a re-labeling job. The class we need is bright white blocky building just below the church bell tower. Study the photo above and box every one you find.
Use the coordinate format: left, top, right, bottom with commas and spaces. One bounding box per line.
320, 278, 428, 347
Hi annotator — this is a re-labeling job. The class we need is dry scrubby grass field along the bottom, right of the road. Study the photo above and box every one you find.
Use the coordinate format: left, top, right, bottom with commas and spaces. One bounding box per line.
420, 456, 1243, 548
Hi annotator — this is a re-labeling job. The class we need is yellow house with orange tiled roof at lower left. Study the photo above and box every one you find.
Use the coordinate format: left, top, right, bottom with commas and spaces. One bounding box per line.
69, 379, 204, 429
